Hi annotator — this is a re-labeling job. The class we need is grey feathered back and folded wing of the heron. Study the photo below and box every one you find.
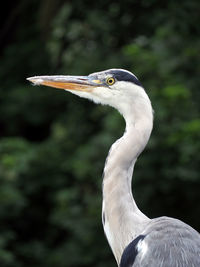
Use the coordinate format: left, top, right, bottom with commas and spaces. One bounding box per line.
120, 217, 200, 267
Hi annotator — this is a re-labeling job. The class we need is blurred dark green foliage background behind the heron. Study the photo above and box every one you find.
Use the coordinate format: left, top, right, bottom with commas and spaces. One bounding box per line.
0, 0, 200, 267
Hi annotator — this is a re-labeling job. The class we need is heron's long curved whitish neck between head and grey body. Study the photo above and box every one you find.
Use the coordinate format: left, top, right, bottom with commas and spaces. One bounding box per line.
102, 96, 153, 264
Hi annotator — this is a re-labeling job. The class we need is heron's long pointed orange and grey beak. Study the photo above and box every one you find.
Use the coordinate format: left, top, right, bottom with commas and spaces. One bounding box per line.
27, 75, 101, 92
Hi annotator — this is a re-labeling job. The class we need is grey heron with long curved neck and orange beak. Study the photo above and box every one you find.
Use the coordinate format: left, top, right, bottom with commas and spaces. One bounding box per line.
27, 69, 200, 267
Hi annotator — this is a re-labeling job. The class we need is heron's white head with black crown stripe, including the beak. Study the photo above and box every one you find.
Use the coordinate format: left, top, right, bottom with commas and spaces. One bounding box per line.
27, 69, 148, 116
